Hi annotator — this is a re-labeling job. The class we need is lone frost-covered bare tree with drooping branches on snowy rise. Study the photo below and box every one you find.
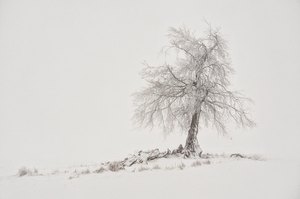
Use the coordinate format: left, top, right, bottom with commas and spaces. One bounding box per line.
134, 28, 254, 156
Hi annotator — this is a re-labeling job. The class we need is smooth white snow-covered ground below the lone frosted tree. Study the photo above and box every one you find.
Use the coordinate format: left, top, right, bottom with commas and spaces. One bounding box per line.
0, 158, 300, 199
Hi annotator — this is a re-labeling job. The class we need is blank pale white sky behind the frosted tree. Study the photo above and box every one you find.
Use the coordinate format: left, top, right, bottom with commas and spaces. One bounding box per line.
0, 0, 300, 168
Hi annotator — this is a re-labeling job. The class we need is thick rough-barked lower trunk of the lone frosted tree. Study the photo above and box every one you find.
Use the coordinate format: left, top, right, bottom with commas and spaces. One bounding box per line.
184, 112, 202, 157
